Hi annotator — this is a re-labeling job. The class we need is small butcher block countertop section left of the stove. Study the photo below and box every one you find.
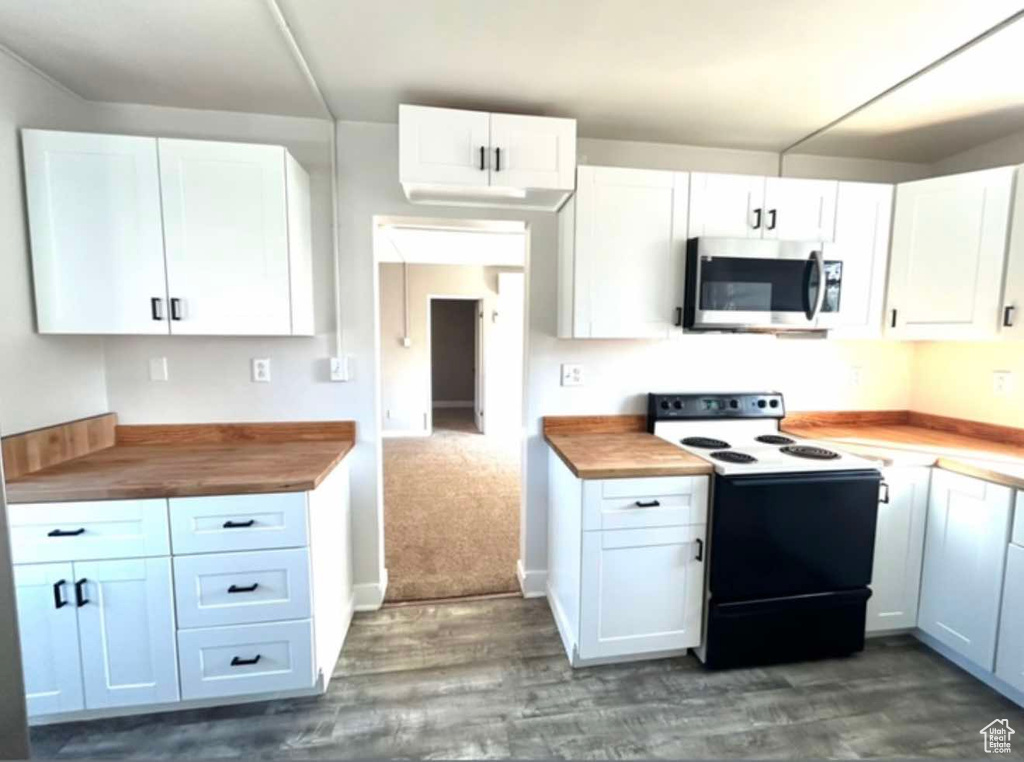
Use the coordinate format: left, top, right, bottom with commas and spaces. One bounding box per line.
544, 416, 714, 479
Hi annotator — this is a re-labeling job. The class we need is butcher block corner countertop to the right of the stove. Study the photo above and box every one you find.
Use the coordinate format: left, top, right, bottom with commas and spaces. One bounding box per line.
781, 411, 1024, 490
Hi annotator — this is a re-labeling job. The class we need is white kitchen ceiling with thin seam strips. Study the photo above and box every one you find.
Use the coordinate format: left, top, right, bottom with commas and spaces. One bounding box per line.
0, 0, 1024, 161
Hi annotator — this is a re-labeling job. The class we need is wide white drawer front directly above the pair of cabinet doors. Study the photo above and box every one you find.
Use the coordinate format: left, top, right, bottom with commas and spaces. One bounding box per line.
7, 499, 170, 563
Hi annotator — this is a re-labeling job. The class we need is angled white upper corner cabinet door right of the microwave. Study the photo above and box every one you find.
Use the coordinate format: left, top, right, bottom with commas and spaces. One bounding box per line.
886, 168, 1014, 340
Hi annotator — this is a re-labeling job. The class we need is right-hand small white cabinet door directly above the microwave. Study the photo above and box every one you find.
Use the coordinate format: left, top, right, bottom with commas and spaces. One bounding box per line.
764, 177, 839, 241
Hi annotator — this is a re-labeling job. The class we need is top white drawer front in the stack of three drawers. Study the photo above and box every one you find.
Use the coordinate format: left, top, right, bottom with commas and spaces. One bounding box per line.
170, 493, 308, 555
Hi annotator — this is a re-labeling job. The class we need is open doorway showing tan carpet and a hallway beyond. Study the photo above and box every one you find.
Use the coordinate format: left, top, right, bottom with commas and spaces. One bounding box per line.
378, 223, 525, 602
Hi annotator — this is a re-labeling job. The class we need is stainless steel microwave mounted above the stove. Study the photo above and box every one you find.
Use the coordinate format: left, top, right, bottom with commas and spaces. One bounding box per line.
683, 238, 843, 331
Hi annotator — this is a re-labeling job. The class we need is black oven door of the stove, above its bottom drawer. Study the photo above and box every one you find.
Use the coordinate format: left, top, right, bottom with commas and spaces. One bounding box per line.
709, 470, 882, 603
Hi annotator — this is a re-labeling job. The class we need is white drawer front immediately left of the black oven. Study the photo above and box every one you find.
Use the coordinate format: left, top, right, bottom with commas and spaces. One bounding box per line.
583, 476, 708, 531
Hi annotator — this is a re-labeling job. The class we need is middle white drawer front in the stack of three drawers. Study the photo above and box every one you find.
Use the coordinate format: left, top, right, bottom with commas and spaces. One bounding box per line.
174, 548, 310, 629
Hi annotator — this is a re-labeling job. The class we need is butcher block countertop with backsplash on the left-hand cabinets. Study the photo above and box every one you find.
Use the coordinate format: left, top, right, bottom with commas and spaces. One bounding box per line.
3, 414, 355, 503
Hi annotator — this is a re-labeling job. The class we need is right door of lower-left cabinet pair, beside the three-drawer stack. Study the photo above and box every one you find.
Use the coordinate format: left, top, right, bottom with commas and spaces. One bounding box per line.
75, 558, 178, 709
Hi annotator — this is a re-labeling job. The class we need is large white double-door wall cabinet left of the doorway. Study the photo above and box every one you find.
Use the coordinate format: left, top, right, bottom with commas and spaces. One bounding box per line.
22, 130, 313, 336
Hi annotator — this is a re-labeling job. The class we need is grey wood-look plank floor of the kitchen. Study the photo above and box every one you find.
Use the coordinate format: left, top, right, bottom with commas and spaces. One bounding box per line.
32, 598, 1024, 759
